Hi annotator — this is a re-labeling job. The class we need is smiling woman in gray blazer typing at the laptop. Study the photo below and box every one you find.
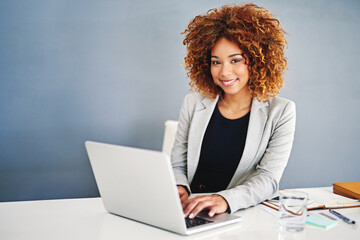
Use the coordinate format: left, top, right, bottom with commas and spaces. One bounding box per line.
171, 4, 295, 218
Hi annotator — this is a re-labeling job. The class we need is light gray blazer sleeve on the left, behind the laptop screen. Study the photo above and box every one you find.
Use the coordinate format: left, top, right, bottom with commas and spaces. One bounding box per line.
171, 94, 194, 192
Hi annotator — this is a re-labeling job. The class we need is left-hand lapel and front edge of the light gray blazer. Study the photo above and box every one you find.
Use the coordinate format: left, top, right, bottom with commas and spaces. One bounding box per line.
188, 96, 219, 183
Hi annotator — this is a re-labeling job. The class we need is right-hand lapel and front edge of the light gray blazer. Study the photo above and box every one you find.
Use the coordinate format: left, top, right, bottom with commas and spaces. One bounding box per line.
228, 99, 268, 188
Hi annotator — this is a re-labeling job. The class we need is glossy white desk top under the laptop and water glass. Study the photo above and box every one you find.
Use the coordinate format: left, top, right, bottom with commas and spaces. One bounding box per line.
0, 188, 360, 240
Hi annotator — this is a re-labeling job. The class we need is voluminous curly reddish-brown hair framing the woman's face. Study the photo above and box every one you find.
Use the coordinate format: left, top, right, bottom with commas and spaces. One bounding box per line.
182, 4, 287, 102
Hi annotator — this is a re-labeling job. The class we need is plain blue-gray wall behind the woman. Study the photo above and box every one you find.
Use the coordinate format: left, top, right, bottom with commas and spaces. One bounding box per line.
0, 0, 360, 201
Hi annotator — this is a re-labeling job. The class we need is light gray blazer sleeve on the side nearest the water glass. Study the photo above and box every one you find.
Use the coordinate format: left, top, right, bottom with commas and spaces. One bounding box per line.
217, 101, 296, 212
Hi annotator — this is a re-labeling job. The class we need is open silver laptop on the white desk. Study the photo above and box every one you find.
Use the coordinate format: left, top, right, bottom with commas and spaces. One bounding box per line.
85, 141, 241, 235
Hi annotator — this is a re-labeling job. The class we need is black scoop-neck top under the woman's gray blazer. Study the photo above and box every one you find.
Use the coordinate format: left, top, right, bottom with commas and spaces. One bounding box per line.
190, 105, 250, 193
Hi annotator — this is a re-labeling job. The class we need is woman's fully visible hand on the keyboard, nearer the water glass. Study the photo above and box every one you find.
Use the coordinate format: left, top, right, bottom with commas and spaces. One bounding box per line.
182, 194, 229, 218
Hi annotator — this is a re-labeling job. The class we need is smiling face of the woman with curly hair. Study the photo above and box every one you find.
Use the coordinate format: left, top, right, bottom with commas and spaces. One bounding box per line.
210, 38, 249, 95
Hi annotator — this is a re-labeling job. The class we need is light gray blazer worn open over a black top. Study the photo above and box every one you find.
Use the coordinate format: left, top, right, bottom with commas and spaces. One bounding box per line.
171, 93, 296, 212
